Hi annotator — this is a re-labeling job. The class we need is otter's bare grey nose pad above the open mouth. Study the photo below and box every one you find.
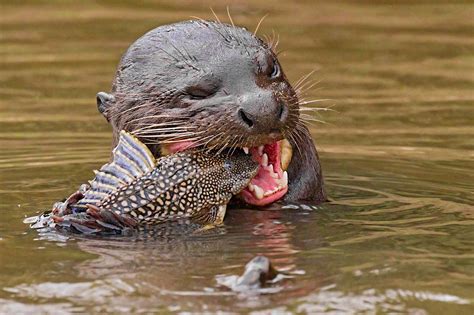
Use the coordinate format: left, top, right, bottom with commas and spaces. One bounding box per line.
237, 92, 286, 131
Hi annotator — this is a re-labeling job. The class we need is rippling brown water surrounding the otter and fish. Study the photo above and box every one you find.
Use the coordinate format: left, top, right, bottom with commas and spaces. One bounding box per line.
0, 0, 474, 314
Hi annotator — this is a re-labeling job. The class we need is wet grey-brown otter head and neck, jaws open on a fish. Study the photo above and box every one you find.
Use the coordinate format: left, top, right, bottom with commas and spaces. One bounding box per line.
97, 21, 325, 205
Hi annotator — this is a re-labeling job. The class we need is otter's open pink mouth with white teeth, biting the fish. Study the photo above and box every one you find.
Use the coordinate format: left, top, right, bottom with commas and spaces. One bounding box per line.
163, 139, 293, 206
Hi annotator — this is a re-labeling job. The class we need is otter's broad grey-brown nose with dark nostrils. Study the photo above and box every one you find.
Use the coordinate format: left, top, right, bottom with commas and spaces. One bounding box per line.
237, 91, 288, 134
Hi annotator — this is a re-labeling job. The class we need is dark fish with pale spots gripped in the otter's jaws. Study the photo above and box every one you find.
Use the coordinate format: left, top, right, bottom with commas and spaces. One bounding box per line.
25, 130, 258, 234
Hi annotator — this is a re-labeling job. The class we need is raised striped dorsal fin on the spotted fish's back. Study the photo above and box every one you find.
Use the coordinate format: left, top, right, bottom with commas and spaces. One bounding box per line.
76, 130, 156, 206
